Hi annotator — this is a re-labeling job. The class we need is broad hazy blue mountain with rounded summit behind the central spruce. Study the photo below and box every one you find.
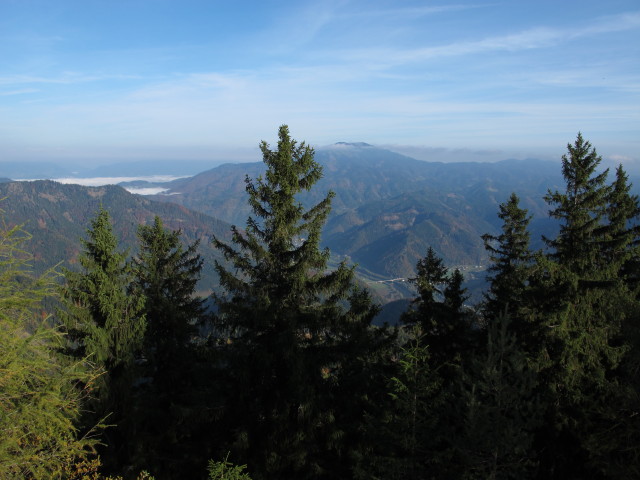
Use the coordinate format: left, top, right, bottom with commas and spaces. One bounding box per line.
148, 143, 561, 278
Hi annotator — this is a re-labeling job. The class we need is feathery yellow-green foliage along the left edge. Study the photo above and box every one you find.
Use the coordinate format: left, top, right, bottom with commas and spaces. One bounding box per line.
0, 215, 94, 479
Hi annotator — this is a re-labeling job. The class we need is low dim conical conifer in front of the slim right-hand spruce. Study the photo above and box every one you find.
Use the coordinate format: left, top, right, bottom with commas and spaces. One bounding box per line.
454, 315, 542, 479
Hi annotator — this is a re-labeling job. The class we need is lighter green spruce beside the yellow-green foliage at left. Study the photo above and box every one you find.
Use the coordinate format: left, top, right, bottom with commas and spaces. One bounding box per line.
58, 207, 146, 469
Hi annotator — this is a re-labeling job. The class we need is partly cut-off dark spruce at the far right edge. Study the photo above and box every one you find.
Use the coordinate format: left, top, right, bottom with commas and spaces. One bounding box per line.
591, 165, 640, 478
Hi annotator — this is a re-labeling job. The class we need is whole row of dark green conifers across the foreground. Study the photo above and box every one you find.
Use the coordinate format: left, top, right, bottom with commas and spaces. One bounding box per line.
0, 126, 640, 480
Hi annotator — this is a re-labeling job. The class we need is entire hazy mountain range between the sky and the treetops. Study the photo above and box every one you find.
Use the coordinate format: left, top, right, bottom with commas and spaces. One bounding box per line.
0, 143, 580, 308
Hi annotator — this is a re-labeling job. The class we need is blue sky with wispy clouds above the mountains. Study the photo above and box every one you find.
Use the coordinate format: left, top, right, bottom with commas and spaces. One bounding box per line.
0, 0, 640, 165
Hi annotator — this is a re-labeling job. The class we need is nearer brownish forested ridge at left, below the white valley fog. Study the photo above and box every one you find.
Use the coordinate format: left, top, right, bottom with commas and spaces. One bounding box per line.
0, 180, 230, 291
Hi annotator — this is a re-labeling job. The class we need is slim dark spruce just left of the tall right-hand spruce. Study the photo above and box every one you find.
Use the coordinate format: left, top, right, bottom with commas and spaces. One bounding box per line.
482, 193, 533, 324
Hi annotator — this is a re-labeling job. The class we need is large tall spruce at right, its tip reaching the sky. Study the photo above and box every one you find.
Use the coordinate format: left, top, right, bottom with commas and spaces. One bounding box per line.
535, 134, 635, 478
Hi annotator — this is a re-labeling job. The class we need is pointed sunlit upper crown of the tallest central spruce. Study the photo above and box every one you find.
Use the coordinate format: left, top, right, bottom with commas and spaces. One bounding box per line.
214, 125, 353, 330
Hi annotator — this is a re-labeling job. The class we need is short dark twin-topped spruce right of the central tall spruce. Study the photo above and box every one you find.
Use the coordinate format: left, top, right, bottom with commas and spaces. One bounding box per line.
398, 248, 477, 478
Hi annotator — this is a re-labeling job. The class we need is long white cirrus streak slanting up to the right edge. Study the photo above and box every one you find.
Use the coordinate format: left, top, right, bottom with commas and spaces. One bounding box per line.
106, 8, 640, 106
